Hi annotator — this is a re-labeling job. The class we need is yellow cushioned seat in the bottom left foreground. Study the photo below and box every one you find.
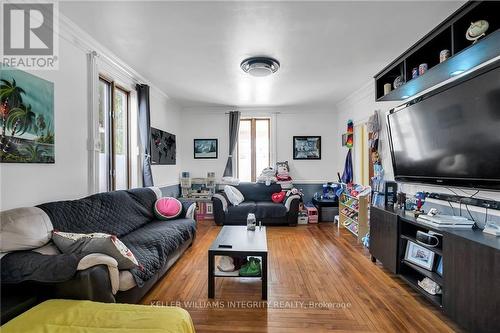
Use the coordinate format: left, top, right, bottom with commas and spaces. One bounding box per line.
0, 300, 195, 333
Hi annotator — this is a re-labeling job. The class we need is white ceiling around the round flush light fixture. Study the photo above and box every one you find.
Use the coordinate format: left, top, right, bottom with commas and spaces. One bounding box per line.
60, 1, 463, 107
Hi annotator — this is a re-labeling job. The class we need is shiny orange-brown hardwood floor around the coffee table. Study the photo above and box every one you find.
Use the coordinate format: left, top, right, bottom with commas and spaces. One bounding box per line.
142, 222, 458, 333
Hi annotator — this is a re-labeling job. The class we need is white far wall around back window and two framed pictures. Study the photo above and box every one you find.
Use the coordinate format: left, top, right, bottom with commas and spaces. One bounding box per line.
179, 108, 337, 183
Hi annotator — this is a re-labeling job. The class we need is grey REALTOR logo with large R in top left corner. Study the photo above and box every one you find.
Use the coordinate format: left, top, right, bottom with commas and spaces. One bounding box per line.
2, 1, 58, 69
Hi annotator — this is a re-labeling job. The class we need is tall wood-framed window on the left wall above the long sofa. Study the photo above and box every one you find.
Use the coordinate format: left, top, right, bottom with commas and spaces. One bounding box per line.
99, 77, 130, 192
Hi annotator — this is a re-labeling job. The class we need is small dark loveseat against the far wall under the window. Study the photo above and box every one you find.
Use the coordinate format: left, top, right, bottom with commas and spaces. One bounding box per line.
212, 183, 300, 226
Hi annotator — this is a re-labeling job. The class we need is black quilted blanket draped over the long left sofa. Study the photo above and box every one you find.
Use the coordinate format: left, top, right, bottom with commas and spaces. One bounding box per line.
38, 188, 196, 287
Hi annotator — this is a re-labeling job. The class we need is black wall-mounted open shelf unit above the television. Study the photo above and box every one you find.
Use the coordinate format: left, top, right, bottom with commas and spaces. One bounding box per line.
374, 1, 500, 102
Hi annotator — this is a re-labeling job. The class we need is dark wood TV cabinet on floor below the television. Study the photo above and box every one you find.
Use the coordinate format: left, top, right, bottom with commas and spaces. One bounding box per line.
370, 206, 500, 333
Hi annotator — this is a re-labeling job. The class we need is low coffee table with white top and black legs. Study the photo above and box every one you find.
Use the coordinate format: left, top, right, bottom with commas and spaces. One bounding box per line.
208, 226, 267, 300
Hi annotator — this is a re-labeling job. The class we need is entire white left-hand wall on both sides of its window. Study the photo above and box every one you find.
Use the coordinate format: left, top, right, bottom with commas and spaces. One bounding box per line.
0, 20, 181, 210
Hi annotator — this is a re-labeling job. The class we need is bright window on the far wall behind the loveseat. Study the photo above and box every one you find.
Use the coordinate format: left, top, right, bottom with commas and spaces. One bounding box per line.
237, 118, 271, 182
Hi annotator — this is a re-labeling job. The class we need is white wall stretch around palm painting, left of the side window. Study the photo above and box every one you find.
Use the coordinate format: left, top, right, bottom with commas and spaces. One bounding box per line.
0, 40, 88, 210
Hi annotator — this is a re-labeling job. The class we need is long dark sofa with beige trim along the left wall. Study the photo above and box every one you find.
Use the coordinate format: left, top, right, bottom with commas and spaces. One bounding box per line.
0, 188, 196, 321
